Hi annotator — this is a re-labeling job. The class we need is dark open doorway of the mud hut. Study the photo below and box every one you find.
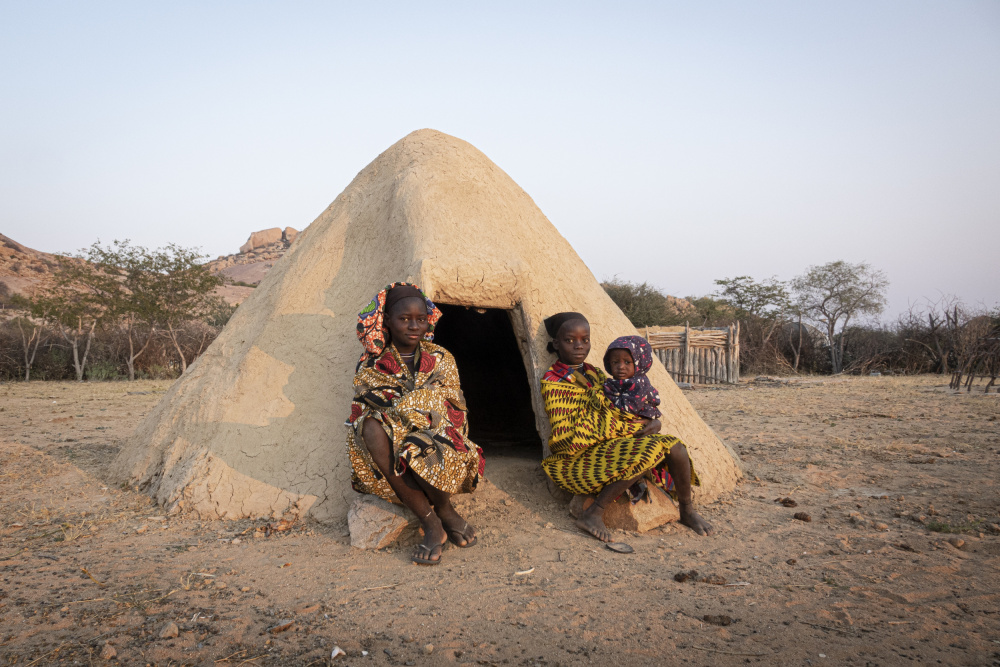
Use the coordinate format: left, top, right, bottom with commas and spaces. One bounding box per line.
434, 303, 542, 457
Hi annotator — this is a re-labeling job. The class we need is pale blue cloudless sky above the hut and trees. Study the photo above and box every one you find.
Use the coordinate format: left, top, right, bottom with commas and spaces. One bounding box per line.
0, 0, 1000, 318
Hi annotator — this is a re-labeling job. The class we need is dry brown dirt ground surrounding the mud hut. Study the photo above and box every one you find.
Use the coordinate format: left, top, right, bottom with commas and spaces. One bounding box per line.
0, 377, 1000, 666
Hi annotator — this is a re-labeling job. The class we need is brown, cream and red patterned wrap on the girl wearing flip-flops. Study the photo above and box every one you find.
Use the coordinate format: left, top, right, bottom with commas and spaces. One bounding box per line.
347, 342, 486, 502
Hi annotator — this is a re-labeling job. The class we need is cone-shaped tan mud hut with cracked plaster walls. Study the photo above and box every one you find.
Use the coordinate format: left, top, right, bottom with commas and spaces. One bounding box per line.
112, 130, 740, 521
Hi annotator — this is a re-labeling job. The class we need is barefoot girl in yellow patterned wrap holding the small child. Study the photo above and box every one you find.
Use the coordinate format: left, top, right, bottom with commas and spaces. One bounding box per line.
542, 313, 712, 542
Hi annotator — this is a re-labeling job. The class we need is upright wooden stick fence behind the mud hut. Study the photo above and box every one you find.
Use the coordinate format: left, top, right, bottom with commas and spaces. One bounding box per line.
646, 322, 740, 384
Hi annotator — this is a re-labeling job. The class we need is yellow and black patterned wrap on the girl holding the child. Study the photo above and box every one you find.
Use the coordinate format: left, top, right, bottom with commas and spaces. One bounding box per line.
542, 362, 701, 494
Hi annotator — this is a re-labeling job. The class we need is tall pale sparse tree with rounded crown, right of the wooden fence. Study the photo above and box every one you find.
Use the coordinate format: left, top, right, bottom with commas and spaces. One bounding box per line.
792, 260, 889, 373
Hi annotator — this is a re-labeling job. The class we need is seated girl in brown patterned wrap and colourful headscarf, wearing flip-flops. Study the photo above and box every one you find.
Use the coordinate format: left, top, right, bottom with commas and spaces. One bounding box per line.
347, 283, 484, 565
